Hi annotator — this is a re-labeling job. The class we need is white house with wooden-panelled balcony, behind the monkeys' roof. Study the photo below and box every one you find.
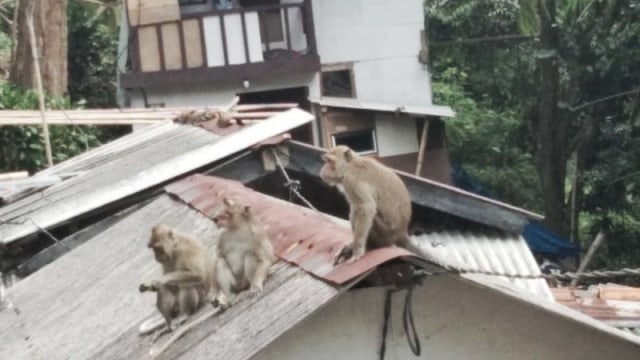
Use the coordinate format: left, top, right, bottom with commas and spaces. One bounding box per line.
119, 0, 454, 183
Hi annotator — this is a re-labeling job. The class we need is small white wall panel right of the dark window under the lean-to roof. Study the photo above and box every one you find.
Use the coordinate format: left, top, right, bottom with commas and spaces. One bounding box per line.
375, 113, 419, 157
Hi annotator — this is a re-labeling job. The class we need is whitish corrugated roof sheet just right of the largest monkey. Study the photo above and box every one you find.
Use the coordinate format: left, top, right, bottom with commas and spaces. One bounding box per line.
411, 231, 553, 300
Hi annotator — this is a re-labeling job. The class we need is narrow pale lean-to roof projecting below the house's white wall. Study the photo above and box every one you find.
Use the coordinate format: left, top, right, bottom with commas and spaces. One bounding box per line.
309, 96, 456, 117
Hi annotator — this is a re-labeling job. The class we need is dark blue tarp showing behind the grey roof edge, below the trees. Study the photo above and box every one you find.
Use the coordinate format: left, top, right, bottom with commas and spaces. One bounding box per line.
451, 165, 580, 259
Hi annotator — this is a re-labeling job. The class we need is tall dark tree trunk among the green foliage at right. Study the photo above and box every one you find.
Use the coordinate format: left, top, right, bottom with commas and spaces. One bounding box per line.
529, 0, 569, 236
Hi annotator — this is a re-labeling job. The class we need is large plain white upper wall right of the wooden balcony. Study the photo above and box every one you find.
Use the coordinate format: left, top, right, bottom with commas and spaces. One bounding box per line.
312, 0, 431, 106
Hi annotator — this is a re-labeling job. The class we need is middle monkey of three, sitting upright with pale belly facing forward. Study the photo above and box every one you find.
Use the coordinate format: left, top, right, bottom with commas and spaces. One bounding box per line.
214, 198, 275, 307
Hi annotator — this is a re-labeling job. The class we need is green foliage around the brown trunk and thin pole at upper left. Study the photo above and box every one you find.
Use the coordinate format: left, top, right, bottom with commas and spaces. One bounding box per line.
0, 0, 119, 173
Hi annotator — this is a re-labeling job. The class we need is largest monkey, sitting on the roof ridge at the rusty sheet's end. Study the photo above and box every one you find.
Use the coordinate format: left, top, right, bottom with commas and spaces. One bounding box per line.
320, 145, 420, 263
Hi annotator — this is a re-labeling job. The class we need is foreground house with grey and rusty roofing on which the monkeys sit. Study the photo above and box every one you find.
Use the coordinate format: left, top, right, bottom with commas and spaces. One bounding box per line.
0, 109, 640, 359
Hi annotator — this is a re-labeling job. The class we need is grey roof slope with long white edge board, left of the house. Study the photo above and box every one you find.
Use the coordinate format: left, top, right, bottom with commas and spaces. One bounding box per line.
0, 109, 313, 243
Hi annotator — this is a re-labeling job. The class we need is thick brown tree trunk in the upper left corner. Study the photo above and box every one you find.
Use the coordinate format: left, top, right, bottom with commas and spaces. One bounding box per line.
9, 0, 67, 96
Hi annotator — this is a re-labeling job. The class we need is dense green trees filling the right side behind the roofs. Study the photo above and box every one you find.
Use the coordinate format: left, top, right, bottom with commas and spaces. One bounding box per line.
425, 0, 640, 268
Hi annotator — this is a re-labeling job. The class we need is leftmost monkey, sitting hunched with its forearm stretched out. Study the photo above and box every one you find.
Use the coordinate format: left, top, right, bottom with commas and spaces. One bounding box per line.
139, 224, 215, 332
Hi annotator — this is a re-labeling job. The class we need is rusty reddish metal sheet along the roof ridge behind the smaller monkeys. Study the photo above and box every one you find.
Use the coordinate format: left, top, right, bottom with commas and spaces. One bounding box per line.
165, 175, 415, 284
